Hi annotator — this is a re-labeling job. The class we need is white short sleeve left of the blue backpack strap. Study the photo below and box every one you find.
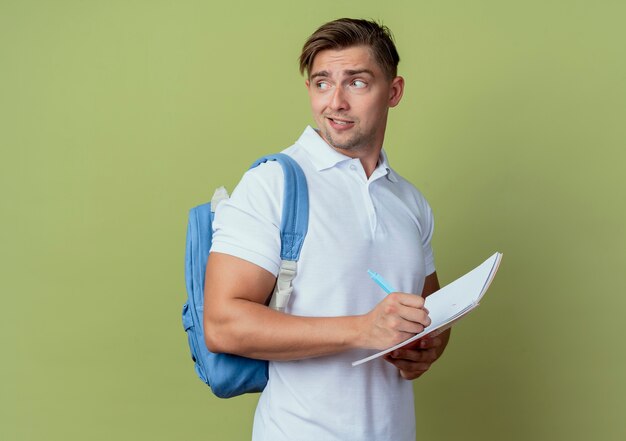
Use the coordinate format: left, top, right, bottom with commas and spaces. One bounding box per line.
211, 161, 284, 275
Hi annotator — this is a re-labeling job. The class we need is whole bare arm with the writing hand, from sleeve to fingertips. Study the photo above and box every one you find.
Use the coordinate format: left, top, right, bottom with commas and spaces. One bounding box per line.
204, 253, 430, 360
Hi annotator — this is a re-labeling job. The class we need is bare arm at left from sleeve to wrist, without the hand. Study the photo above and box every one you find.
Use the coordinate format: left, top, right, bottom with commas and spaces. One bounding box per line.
204, 253, 360, 360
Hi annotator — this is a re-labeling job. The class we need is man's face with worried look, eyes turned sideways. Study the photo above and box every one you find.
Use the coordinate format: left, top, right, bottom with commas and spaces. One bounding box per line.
306, 46, 404, 157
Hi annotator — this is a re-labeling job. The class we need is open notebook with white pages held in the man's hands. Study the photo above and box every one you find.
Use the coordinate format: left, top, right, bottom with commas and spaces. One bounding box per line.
352, 253, 502, 366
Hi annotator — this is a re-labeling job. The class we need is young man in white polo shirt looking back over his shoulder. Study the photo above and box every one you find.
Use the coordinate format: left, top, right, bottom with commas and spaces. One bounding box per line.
205, 19, 449, 441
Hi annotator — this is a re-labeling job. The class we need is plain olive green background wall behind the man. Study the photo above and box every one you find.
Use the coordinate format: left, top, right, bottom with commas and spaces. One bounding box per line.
0, 0, 626, 441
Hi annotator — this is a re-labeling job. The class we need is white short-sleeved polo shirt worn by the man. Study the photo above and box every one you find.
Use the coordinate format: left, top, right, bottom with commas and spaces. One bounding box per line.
211, 127, 435, 441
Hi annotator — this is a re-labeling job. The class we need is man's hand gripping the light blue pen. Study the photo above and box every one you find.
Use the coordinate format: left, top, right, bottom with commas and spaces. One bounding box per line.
362, 292, 430, 350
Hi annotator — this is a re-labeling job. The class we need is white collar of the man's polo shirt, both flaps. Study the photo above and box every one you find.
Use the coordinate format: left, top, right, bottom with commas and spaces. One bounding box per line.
297, 126, 398, 182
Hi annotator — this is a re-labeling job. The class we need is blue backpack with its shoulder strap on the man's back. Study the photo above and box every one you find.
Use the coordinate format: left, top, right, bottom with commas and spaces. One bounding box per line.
183, 153, 309, 398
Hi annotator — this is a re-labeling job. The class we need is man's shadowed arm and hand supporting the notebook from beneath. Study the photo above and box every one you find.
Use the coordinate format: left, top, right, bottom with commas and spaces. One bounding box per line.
385, 272, 451, 380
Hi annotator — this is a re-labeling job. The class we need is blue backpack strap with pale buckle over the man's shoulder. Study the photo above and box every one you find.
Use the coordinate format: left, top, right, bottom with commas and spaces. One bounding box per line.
250, 153, 309, 311
